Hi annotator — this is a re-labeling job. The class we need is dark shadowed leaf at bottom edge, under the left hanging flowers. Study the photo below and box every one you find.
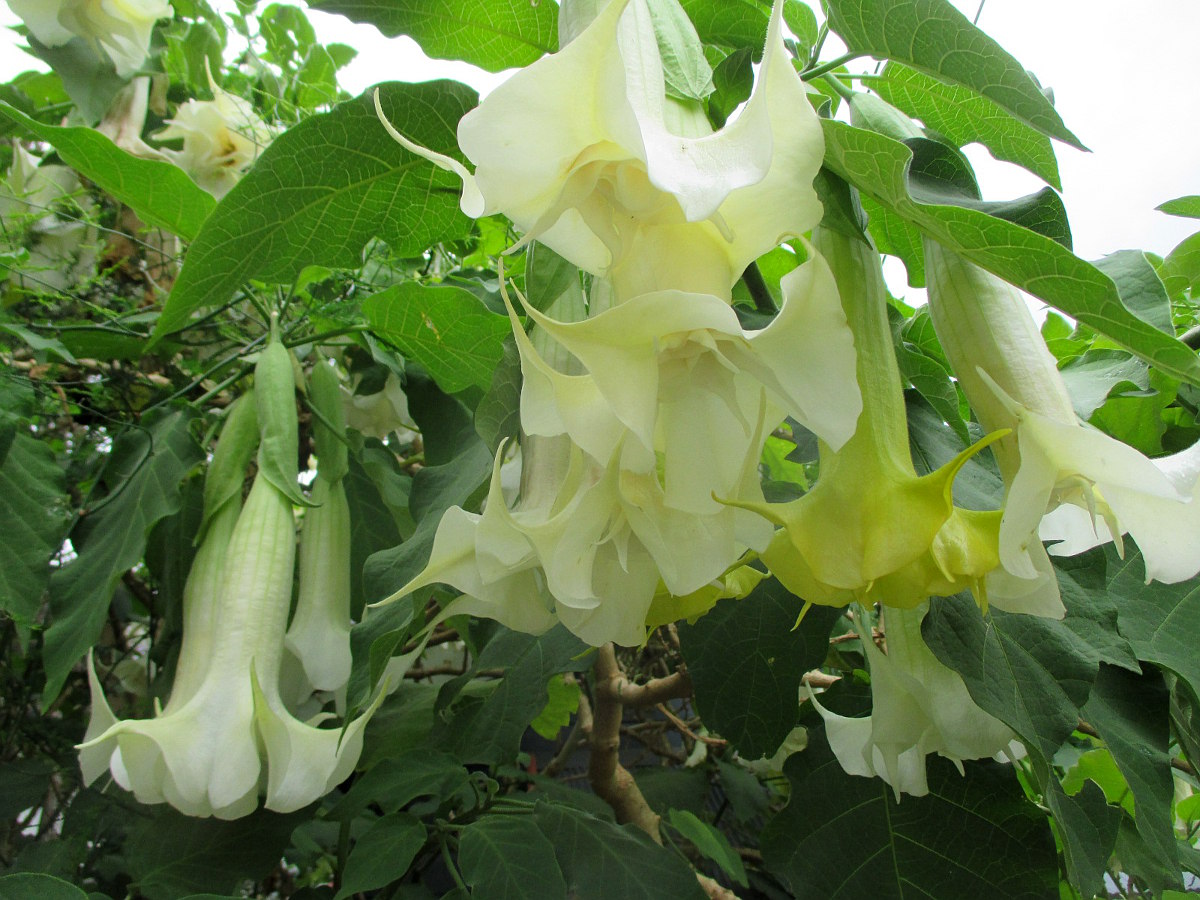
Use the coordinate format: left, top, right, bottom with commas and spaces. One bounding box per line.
125, 804, 311, 900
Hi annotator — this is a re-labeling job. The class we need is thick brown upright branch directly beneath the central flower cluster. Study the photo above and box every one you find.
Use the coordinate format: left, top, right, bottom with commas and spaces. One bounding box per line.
588, 643, 666, 844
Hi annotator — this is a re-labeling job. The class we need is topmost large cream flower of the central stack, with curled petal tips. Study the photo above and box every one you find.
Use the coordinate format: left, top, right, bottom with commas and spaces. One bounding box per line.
379, 0, 824, 302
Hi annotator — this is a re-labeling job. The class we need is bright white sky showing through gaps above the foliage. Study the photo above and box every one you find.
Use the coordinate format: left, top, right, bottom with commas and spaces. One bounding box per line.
0, 0, 1200, 259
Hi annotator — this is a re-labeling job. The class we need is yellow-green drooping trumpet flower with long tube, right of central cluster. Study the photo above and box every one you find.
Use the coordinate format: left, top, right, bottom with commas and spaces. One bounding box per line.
734, 228, 1000, 607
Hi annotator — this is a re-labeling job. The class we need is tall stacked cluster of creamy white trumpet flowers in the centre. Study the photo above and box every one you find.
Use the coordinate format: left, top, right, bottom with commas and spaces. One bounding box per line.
384, 0, 862, 644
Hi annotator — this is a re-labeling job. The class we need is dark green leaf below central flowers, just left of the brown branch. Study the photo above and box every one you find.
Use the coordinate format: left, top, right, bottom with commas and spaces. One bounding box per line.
433, 625, 588, 764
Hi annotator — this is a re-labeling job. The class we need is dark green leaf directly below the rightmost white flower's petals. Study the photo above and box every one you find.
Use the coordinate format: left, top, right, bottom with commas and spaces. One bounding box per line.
922, 596, 1099, 760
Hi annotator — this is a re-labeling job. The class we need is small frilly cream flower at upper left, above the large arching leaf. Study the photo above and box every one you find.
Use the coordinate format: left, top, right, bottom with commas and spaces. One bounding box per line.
154, 77, 274, 199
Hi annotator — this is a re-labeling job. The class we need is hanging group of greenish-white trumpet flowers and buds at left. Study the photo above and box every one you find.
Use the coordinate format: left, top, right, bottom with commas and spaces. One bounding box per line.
80, 342, 382, 818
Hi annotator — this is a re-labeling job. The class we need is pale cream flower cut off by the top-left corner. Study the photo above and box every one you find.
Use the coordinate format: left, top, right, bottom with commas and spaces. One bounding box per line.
8, 0, 174, 78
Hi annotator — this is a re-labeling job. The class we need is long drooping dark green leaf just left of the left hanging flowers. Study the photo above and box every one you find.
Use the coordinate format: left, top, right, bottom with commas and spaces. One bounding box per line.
42, 410, 204, 709
